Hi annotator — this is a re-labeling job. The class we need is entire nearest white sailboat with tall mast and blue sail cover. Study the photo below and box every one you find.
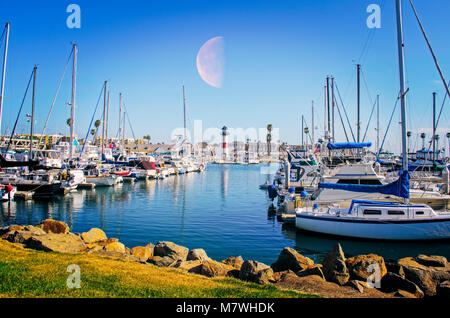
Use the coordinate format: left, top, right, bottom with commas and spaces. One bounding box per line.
295, 0, 450, 240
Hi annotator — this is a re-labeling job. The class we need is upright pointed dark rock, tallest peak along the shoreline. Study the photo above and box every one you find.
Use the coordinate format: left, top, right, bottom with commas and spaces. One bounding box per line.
322, 244, 350, 286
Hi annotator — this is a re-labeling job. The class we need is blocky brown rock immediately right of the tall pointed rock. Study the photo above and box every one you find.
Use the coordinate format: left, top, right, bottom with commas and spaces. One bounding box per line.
345, 254, 387, 281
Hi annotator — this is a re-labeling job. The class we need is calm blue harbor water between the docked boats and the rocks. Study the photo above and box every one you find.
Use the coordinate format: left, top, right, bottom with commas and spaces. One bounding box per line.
0, 165, 450, 264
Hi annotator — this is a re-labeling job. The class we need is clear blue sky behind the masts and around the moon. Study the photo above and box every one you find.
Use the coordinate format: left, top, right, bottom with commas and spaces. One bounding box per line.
0, 0, 450, 151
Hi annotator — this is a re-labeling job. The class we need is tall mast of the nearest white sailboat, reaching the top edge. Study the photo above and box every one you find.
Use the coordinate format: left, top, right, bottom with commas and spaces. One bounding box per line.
396, 0, 409, 203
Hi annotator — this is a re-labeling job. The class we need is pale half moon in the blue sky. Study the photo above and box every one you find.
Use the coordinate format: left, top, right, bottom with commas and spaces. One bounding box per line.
197, 36, 225, 88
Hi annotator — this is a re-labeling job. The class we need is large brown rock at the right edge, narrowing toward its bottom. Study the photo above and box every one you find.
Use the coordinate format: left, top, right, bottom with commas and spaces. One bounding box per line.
398, 257, 450, 297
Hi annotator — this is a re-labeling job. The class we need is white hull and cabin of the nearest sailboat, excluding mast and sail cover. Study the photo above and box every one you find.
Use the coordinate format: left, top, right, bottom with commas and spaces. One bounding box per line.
295, 200, 450, 240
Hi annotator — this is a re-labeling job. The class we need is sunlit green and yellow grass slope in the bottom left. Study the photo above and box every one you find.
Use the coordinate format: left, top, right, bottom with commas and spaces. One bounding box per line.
0, 241, 315, 298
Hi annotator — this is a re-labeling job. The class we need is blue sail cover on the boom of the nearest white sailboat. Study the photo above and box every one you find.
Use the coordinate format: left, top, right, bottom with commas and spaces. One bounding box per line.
319, 171, 409, 199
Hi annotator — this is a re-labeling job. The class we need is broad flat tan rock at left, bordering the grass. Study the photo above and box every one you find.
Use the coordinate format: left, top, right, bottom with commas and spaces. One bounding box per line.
24, 233, 85, 253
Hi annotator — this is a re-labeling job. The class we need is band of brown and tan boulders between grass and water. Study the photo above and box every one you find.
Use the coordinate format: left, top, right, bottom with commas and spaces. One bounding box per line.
0, 220, 450, 298
